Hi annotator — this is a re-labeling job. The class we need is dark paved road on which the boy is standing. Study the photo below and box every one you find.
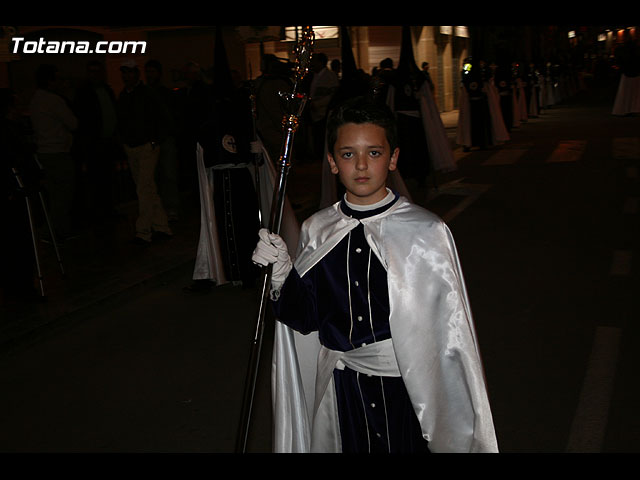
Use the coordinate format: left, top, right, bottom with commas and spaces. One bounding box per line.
0, 82, 640, 453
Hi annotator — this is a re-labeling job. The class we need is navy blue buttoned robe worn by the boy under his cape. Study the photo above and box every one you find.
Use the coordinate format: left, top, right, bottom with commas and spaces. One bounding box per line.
273, 195, 429, 453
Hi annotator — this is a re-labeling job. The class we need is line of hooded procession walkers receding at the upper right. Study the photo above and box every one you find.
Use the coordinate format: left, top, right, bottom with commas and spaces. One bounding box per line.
456, 34, 640, 151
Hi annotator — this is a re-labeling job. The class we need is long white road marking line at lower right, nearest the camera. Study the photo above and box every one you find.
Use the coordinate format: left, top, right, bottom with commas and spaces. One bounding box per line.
567, 327, 620, 453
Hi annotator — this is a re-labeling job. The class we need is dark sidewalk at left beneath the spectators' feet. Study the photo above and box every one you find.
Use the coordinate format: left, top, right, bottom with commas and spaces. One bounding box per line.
0, 111, 458, 351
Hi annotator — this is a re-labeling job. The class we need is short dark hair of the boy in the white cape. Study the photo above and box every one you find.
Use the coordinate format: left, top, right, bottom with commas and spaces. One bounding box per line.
327, 97, 398, 154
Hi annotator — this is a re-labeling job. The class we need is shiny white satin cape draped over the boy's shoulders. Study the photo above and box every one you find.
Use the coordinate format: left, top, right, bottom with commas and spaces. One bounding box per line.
272, 197, 498, 453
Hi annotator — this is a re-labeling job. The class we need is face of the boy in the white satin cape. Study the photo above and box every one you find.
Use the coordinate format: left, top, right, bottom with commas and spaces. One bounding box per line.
328, 123, 399, 205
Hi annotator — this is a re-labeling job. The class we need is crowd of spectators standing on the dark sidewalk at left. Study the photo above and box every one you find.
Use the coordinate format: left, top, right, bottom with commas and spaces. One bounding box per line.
2, 59, 225, 297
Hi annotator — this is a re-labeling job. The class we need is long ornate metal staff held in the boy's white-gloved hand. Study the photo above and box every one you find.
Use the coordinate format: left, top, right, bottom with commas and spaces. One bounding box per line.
236, 27, 314, 453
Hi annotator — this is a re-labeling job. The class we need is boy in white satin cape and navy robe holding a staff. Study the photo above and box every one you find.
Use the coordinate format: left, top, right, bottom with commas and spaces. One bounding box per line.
253, 98, 497, 453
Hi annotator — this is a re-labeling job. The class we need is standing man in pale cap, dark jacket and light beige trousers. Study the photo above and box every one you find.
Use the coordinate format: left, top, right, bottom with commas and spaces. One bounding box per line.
118, 60, 172, 245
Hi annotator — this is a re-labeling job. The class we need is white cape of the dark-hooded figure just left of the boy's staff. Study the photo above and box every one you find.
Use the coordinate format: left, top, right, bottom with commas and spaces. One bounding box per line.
193, 142, 300, 285
